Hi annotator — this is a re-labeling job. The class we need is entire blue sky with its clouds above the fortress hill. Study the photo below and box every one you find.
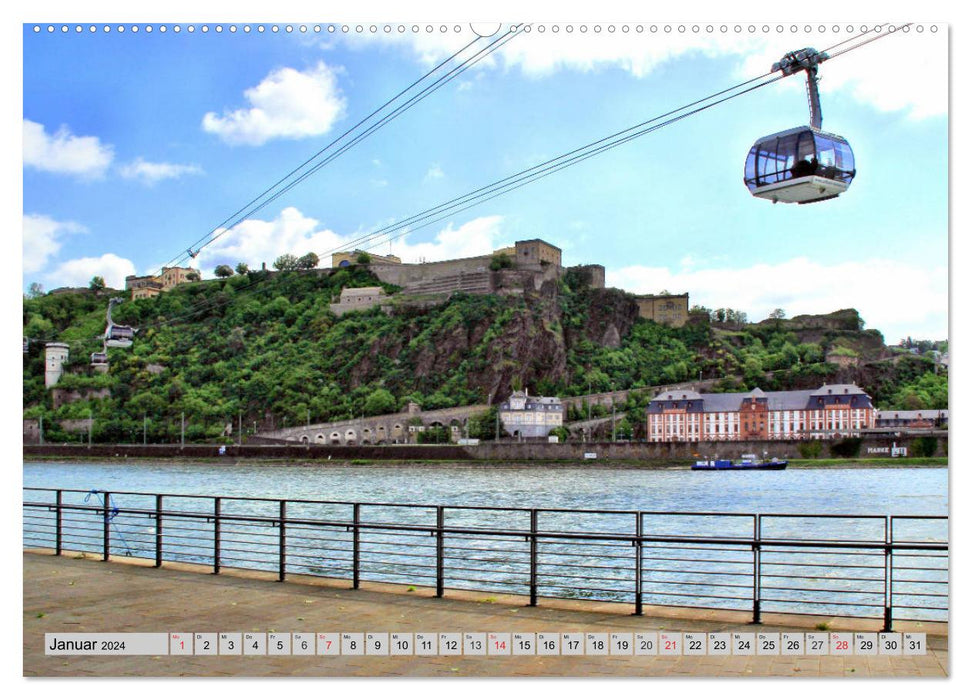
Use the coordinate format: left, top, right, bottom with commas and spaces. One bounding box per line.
23, 17, 948, 343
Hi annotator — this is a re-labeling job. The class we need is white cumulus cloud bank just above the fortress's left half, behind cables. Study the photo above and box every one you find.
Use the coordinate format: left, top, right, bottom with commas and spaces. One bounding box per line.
195, 207, 502, 276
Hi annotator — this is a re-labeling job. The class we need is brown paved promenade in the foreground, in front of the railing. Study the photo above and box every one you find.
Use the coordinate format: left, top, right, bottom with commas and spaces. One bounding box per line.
23, 552, 948, 678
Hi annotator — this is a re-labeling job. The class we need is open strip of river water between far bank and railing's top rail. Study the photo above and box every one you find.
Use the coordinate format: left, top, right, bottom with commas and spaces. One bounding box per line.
24, 462, 948, 515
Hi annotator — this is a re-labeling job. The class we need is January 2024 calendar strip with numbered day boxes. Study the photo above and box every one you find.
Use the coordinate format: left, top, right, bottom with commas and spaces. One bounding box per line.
44, 631, 927, 657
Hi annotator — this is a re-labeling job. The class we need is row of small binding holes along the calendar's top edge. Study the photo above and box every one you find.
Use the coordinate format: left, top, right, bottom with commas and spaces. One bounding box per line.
32, 23, 939, 35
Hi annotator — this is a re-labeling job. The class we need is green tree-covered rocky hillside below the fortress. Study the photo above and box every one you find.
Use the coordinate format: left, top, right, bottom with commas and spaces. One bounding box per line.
23, 264, 947, 442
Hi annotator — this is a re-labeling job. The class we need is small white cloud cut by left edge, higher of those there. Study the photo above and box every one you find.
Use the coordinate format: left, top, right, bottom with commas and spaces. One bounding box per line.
23, 119, 114, 178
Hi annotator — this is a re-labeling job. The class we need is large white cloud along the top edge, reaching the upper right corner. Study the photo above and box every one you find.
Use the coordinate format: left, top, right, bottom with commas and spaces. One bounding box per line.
350, 23, 948, 119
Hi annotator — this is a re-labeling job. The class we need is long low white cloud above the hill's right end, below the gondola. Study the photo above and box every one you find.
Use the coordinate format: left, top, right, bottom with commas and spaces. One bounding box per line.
607, 257, 948, 343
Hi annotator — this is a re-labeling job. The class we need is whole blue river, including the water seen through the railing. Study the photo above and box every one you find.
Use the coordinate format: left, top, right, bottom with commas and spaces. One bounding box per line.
23, 462, 948, 620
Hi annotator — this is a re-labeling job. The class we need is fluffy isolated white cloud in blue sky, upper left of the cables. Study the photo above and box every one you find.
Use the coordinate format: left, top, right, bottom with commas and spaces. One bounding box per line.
202, 62, 346, 146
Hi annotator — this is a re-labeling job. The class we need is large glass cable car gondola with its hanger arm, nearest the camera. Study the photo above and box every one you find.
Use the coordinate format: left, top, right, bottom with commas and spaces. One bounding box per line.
745, 49, 856, 204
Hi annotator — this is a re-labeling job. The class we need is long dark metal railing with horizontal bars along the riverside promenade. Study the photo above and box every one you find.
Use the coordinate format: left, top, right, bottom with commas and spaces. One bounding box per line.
23, 488, 948, 631
